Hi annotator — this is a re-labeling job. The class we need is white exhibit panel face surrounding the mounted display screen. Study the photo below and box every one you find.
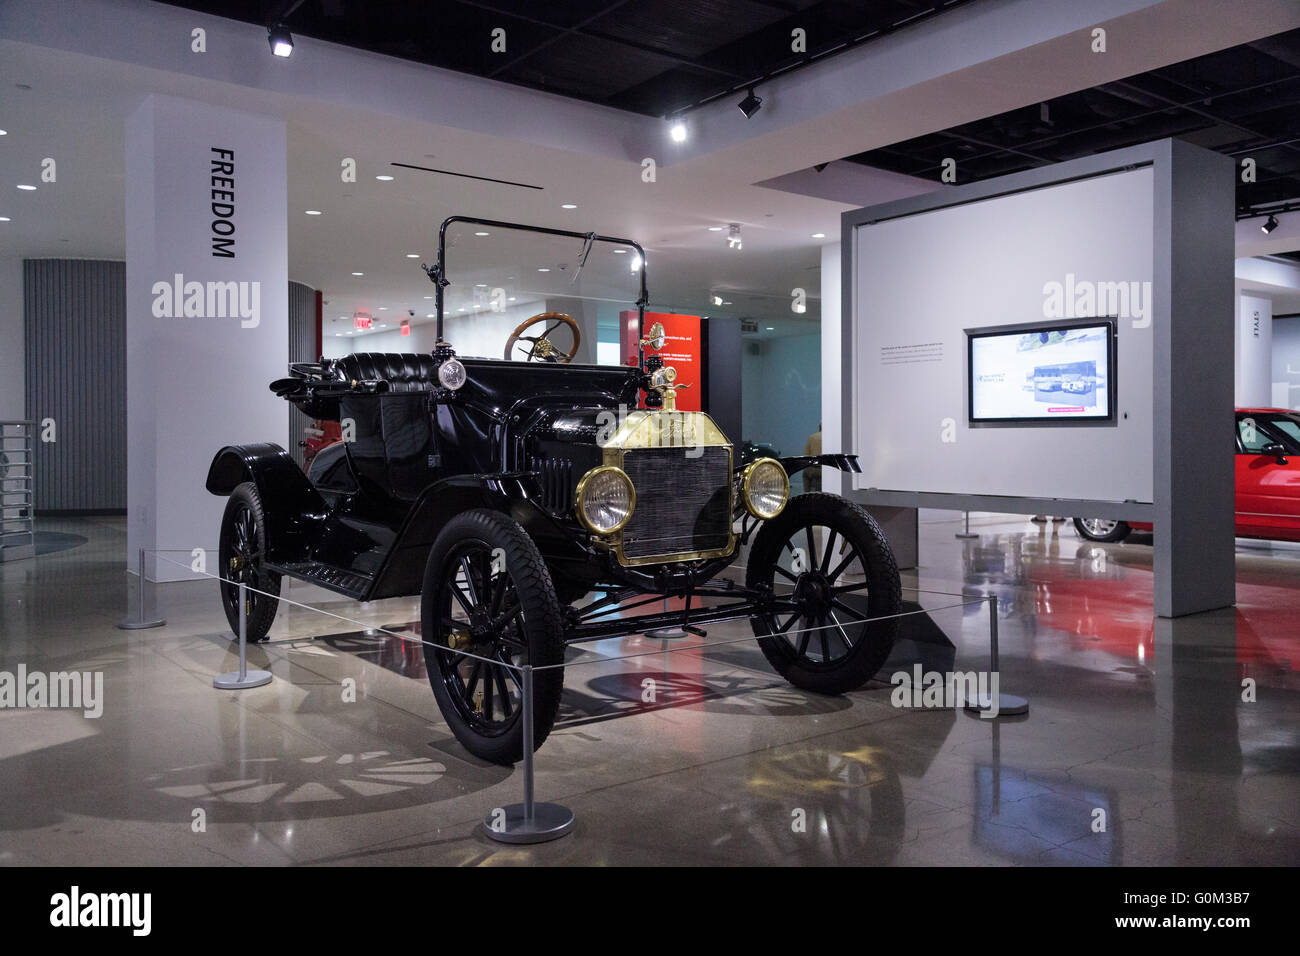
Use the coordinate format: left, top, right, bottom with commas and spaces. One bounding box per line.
849, 166, 1154, 502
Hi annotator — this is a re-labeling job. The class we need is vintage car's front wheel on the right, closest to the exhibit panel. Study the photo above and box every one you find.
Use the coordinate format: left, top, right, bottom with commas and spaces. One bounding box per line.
745, 492, 902, 695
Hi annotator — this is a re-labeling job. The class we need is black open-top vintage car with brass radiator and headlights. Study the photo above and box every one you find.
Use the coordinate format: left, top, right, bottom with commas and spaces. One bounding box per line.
207, 216, 901, 763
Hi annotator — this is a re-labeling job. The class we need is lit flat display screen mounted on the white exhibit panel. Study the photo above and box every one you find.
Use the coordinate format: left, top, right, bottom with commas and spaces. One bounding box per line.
967, 320, 1114, 423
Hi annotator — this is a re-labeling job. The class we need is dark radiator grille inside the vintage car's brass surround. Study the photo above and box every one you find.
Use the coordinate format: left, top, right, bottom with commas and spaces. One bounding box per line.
623, 446, 732, 559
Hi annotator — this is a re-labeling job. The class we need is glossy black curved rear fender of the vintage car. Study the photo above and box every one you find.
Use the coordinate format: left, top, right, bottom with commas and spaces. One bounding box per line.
207, 442, 329, 564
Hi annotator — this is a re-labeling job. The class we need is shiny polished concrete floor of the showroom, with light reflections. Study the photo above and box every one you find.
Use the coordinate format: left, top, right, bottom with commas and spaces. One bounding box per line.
0, 512, 1300, 865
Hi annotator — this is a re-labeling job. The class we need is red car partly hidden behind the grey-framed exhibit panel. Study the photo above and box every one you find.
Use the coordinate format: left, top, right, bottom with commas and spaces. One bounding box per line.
1074, 408, 1300, 541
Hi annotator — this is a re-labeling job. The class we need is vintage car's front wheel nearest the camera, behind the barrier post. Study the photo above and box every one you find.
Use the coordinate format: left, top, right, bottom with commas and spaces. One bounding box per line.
420, 509, 564, 765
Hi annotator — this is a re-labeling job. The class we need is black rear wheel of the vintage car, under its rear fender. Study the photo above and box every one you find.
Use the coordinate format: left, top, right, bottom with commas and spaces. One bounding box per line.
217, 481, 280, 644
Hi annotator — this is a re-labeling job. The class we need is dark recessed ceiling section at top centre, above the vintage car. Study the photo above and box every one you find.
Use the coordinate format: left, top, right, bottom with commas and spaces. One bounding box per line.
154, 0, 974, 116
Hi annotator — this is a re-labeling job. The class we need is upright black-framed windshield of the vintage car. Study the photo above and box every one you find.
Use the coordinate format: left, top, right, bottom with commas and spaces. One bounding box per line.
442, 221, 642, 364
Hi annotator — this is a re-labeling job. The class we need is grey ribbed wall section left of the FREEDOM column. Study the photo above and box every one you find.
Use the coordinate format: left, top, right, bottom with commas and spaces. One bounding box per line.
23, 259, 126, 511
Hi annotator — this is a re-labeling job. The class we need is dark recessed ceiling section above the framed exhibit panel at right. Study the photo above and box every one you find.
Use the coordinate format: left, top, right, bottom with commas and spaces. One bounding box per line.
848, 30, 1300, 219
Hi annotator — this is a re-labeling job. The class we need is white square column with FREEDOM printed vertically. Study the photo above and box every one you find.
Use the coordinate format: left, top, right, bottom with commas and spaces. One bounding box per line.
126, 95, 289, 580
